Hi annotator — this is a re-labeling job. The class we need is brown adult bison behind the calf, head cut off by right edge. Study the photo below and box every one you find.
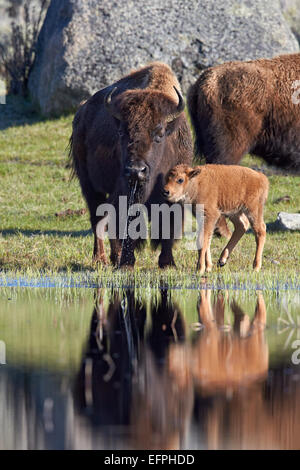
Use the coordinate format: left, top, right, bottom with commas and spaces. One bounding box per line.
188, 54, 300, 171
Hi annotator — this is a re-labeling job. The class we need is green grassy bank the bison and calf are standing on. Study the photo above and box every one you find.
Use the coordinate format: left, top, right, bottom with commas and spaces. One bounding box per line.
0, 96, 300, 287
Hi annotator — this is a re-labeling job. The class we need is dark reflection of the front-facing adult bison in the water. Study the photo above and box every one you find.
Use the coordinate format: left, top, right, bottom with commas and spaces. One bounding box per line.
76, 290, 192, 449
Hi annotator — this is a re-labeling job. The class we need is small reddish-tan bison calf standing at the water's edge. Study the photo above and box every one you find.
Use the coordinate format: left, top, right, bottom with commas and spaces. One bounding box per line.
164, 165, 269, 274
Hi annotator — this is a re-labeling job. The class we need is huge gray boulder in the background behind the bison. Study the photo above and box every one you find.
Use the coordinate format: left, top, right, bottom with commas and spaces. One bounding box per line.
29, 0, 299, 114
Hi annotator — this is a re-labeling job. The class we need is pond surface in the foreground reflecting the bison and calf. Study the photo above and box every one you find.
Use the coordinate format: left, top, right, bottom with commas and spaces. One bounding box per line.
0, 288, 300, 450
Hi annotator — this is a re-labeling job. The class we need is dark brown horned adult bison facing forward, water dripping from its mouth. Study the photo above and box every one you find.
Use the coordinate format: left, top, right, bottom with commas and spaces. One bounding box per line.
70, 62, 193, 268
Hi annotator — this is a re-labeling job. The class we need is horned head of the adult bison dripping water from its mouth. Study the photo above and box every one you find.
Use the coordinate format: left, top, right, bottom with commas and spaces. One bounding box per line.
105, 87, 184, 191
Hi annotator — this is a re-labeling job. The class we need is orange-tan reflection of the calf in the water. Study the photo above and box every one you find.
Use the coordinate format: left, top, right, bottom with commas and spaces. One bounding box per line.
192, 291, 269, 395
